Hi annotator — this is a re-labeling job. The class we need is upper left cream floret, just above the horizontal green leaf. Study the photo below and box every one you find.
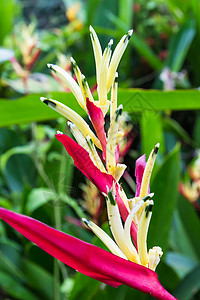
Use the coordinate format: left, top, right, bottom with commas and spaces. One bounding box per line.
47, 64, 87, 112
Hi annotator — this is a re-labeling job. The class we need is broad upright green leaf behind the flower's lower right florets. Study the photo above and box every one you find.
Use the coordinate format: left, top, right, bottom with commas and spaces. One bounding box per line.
148, 145, 180, 252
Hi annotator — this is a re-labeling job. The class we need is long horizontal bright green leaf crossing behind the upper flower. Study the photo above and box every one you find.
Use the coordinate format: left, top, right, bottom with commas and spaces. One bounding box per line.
0, 89, 200, 127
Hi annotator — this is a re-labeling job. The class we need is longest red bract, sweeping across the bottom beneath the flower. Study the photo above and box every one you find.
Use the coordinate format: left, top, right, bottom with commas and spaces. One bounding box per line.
0, 208, 175, 300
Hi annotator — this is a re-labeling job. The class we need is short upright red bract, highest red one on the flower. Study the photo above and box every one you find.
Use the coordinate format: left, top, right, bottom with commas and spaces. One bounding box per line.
86, 98, 106, 156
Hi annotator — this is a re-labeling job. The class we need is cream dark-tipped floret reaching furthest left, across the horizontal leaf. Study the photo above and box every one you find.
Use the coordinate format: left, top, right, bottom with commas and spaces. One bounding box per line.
40, 97, 102, 150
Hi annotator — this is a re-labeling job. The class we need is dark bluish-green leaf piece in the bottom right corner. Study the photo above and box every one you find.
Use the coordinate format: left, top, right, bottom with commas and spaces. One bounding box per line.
174, 265, 200, 300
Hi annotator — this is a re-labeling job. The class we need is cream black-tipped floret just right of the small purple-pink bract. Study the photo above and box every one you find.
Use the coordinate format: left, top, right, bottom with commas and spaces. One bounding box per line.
139, 143, 160, 198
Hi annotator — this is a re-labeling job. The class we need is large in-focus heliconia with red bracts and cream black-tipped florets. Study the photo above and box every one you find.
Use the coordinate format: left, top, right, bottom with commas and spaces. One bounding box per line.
0, 27, 175, 299
